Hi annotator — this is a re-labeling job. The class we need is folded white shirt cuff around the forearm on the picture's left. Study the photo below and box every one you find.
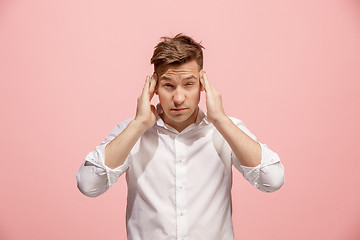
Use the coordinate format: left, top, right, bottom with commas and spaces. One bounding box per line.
85, 142, 129, 188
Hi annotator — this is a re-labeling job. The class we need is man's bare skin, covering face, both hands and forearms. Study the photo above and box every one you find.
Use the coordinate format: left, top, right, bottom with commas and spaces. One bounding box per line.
105, 60, 261, 169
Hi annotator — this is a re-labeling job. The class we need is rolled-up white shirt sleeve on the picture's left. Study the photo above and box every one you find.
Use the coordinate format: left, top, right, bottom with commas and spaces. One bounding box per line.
76, 119, 132, 197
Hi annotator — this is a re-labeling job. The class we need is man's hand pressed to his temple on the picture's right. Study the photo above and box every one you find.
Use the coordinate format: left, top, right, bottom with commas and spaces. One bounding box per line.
200, 70, 227, 126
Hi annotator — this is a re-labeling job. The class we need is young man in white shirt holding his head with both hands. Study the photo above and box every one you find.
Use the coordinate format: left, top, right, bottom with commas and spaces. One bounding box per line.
76, 34, 284, 240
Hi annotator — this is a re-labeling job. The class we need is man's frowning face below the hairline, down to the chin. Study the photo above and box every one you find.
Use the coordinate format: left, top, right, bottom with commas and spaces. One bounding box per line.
157, 60, 202, 131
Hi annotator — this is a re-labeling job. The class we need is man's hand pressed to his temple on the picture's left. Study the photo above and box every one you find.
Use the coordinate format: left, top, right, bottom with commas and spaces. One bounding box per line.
135, 73, 156, 129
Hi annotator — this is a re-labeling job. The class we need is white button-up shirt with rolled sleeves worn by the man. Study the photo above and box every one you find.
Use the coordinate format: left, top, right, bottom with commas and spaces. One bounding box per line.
76, 107, 284, 240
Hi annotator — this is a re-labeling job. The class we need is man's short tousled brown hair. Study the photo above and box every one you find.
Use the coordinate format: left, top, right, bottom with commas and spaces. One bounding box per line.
150, 33, 205, 75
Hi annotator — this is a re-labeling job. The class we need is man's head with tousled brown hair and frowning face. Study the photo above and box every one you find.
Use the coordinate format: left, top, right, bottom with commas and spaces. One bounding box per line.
151, 34, 204, 131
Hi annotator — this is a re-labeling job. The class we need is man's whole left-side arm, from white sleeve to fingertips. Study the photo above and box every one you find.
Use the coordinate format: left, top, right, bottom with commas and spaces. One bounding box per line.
76, 74, 156, 197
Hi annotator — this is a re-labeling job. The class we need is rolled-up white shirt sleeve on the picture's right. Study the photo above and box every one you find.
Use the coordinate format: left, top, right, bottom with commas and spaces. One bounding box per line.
231, 118, 285, 192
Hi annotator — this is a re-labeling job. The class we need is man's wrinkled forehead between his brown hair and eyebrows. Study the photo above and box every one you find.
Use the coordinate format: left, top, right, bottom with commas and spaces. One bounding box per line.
159, 60, 199, 79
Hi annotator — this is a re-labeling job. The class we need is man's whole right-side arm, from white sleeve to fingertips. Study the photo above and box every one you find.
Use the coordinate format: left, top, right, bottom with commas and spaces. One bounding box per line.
200, 70, 284, 192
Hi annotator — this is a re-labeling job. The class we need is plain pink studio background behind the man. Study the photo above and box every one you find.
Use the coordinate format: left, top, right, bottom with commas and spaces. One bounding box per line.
0, 0, 360, 240
